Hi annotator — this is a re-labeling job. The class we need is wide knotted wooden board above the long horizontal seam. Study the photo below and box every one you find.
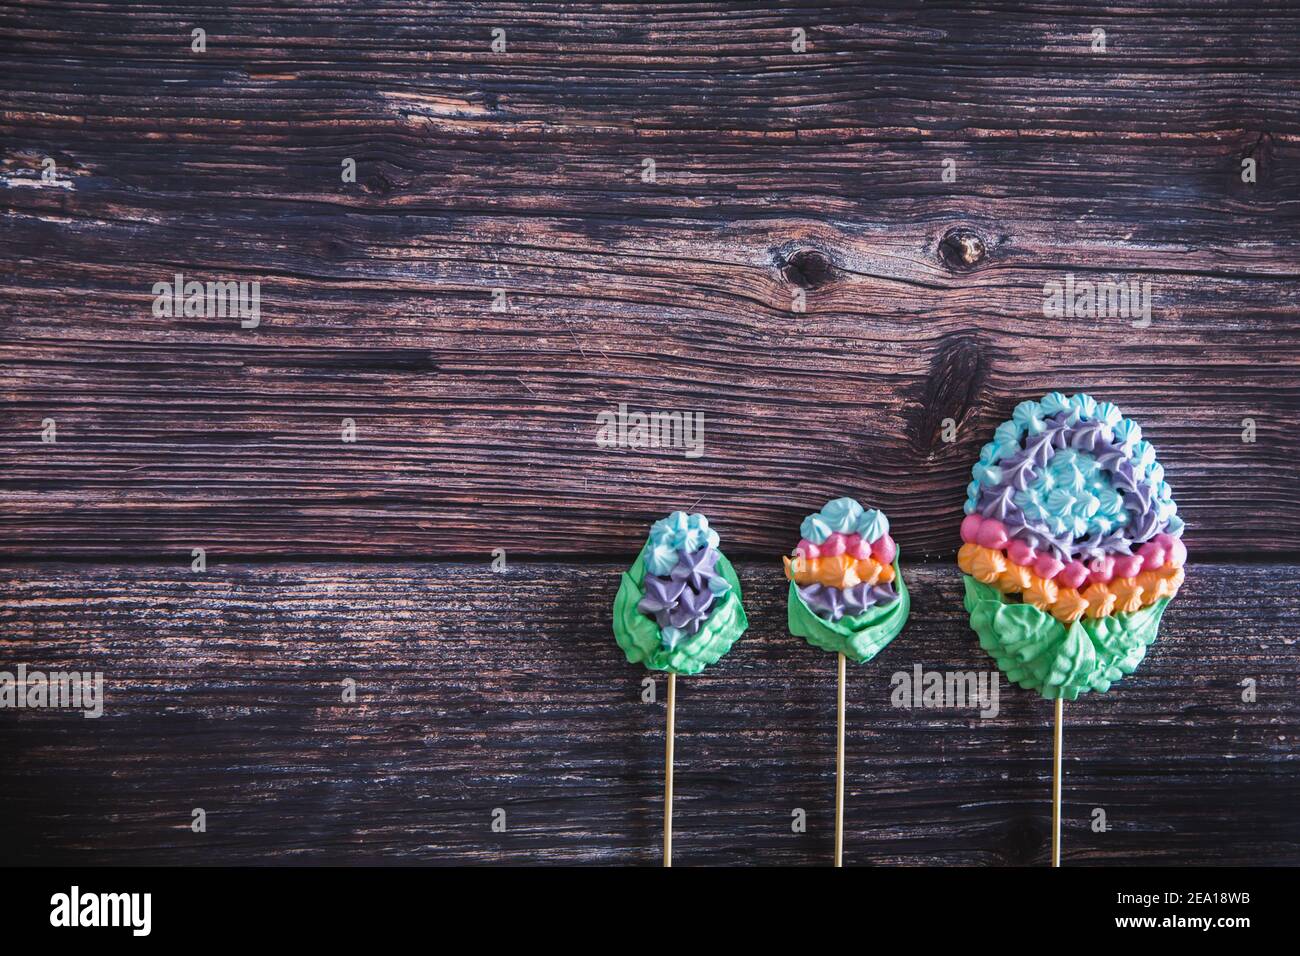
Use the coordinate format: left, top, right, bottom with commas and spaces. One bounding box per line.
0, 3, 1300, 559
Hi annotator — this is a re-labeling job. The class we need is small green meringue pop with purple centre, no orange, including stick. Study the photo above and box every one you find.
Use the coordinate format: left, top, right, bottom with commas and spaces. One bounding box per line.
614, 511, 749, 866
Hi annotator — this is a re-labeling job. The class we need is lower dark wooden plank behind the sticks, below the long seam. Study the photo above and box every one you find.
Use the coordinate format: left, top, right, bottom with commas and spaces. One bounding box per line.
0, 562, 1300, 865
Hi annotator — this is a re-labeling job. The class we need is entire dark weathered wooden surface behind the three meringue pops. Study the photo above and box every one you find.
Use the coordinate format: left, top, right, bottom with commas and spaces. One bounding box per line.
0, 0, 1300, 864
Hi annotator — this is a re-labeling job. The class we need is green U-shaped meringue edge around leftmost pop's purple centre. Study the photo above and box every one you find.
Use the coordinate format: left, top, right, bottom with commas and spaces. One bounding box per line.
614, 541, 749, 675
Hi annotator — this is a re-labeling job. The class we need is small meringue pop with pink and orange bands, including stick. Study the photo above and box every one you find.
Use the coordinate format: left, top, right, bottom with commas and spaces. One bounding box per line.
784, 498, 911, 866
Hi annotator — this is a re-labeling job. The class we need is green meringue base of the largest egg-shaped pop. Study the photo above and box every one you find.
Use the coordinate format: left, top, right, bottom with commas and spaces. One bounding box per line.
962, 575, 1169, 700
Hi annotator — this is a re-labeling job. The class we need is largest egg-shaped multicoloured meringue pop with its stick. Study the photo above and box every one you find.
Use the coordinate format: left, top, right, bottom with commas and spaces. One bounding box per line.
957, 392, 1187, 866
